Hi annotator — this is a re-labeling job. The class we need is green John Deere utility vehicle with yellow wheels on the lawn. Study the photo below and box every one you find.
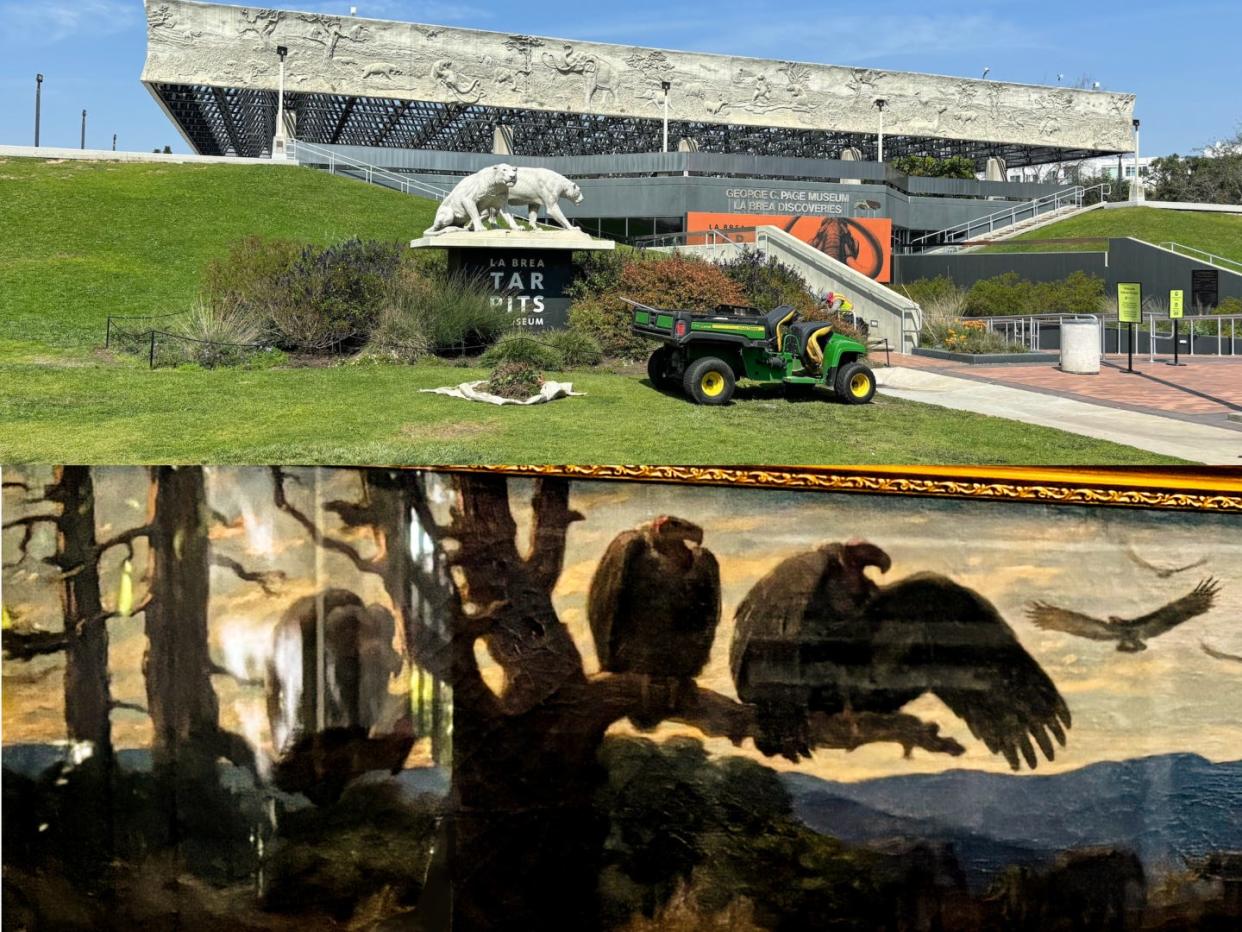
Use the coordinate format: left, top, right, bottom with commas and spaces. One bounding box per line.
626, 301, 876, 405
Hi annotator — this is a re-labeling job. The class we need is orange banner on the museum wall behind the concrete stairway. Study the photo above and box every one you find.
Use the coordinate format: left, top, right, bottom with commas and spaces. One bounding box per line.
686, 210, 893, 282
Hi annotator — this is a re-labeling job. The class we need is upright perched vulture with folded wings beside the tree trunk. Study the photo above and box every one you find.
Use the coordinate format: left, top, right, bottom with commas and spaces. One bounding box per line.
586, 514, 720, 728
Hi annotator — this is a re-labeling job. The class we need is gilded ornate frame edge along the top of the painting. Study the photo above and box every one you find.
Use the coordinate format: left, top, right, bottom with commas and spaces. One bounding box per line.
426, 466, 1242, 514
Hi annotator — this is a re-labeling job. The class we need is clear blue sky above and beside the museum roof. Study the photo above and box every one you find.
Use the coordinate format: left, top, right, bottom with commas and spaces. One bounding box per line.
0, 0, 1242, 155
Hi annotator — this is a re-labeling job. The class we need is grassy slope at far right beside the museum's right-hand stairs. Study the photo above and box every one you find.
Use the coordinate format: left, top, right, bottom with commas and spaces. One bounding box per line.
981, 208, 1242, 262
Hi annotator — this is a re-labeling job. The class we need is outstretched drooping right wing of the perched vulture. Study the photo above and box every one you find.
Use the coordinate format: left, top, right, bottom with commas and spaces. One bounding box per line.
868, 574, 1069, 770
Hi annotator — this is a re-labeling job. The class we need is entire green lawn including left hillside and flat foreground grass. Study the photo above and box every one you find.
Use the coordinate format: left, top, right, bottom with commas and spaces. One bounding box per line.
0, 159, 1187, 465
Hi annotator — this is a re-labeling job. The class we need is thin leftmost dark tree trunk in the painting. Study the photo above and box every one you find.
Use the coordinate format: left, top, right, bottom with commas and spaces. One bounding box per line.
47, 466, 112, 761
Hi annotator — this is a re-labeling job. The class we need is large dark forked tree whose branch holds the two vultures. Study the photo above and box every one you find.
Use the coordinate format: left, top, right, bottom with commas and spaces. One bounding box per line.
274, 470, 963, 930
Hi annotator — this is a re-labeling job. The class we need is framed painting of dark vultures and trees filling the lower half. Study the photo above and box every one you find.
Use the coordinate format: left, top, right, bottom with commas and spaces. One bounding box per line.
2, 466, 1242, 932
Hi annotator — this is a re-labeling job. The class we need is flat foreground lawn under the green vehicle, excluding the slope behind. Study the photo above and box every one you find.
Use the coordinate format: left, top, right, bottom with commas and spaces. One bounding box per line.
0, 357, 1171, 465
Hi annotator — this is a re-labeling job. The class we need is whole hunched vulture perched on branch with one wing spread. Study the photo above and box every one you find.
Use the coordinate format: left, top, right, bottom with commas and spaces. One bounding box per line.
729, 541, 1069, 770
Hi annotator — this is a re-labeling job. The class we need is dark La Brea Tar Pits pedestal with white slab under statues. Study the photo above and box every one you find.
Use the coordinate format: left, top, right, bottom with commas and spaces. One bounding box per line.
410, 230, 616, 331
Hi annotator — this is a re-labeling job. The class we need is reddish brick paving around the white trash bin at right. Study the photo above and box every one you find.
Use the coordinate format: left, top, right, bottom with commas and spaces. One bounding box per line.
893, 353, 1242, 426
